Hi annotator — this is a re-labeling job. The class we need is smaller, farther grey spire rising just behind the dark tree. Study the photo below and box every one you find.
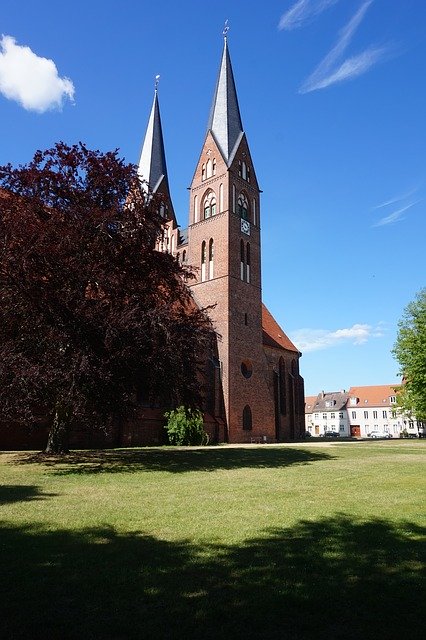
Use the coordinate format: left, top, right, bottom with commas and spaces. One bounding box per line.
138, 76, 168, 192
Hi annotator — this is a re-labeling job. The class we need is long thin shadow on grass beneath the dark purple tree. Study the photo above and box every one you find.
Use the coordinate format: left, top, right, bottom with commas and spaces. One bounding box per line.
13, 446, 334, 475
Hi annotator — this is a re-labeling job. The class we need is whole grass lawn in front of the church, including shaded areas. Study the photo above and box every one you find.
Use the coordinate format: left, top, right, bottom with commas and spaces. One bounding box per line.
0, 440, 426, 640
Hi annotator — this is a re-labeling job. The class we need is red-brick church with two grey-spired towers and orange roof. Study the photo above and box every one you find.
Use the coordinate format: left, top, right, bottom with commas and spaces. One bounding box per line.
135, 35, 305, 445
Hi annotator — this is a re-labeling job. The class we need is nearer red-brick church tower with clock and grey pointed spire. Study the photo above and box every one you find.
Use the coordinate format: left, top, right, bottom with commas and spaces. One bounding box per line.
188, 36, 277, 442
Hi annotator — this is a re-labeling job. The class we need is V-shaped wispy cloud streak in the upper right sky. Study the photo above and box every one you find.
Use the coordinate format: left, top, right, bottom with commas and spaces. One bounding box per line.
299, 0, 387, 93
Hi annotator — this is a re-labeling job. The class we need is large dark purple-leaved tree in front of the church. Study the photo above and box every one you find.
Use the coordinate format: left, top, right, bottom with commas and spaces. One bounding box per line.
0, 143, 212, 453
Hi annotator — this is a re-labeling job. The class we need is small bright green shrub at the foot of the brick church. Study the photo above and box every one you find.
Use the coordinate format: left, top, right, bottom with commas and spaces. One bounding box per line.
164, 406, 208, 446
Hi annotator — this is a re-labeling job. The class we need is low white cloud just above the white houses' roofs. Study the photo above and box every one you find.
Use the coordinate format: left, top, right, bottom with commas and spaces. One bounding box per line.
291, 323, 384, 353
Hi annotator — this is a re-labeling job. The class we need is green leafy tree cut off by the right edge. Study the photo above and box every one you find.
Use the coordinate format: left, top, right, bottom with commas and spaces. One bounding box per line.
392, 288, 426, 420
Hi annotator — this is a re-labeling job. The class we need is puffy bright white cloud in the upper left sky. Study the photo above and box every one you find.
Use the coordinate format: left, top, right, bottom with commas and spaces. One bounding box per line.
0, 36, 74, 113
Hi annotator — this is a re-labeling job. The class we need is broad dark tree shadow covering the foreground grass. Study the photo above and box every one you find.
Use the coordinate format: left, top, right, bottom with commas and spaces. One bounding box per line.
0, 515, 424, 640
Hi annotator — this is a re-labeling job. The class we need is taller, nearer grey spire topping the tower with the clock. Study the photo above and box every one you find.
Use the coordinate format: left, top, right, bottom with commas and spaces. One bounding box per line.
207, 34, 243, 162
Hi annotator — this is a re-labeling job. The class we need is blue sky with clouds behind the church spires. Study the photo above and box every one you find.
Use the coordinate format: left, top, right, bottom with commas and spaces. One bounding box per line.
0, 0, 426, 395
